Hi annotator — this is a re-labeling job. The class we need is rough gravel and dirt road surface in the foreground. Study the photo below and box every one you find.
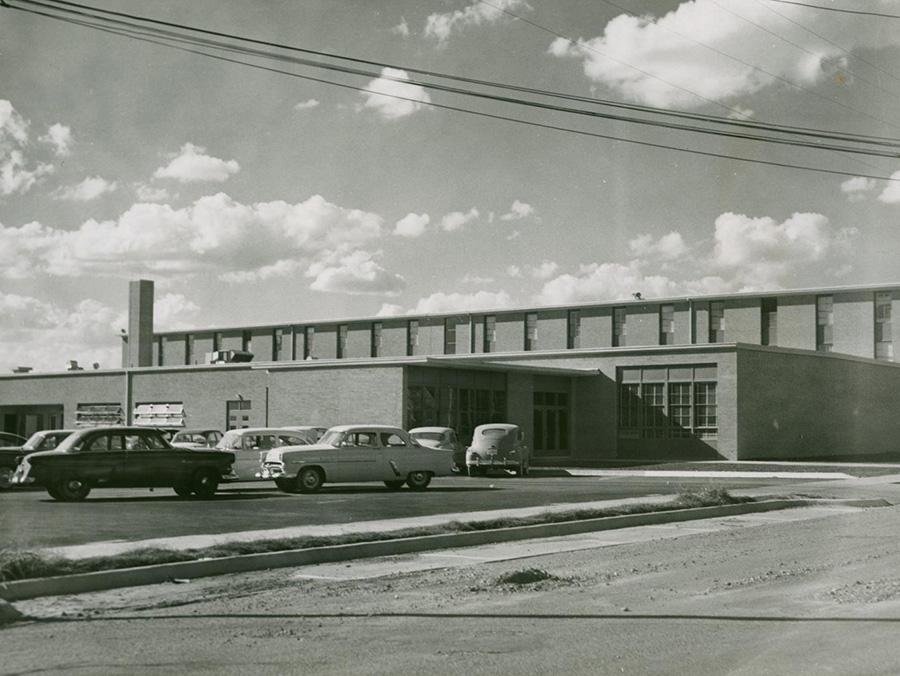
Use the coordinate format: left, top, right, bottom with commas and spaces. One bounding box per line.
0, 507, 900, 674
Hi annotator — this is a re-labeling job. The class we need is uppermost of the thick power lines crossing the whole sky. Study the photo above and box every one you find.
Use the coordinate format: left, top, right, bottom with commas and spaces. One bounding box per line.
17, 0, 898, 146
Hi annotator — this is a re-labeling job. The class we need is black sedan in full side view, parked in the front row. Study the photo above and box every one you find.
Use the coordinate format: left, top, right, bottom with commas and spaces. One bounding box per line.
12, 427, 234, 501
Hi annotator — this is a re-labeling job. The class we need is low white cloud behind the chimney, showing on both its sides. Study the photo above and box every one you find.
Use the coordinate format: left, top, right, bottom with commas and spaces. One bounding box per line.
0, 292, 199, 371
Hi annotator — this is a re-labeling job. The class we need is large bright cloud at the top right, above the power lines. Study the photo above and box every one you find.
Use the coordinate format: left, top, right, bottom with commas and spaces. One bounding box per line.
548, 0, 900, 110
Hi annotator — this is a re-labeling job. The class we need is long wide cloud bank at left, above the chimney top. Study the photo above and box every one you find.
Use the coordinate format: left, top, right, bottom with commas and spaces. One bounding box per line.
0, 193, 396, 292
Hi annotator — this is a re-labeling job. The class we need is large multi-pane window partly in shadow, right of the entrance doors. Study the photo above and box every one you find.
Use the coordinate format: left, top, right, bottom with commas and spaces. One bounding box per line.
617, 364, 719, 439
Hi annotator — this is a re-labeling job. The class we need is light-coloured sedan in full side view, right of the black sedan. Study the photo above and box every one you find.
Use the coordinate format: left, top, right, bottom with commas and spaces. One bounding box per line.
262, 425, 452, 493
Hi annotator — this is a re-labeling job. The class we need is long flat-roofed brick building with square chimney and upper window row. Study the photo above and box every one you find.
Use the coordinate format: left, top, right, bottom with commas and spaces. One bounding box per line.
0, 281, 900, 464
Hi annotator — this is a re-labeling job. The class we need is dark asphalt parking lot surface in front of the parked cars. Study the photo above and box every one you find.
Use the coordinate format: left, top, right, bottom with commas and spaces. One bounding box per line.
0, 475, 797, 549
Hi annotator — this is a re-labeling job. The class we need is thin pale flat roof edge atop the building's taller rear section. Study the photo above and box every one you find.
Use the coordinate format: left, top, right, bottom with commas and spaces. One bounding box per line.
153, 282, 900, 336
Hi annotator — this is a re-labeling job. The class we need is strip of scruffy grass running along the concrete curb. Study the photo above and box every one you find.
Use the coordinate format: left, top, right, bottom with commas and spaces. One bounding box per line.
0, 488, 753, 582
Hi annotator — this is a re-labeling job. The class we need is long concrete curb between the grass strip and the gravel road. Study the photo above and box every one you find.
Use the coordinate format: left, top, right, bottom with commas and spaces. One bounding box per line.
0, 499, 891, 601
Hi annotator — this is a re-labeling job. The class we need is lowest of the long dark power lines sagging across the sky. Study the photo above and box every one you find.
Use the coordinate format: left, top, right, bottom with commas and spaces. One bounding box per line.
4, 0, 900, 181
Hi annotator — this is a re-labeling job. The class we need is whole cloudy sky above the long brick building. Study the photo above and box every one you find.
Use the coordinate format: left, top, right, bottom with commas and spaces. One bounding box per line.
0, 0, 900, 372
